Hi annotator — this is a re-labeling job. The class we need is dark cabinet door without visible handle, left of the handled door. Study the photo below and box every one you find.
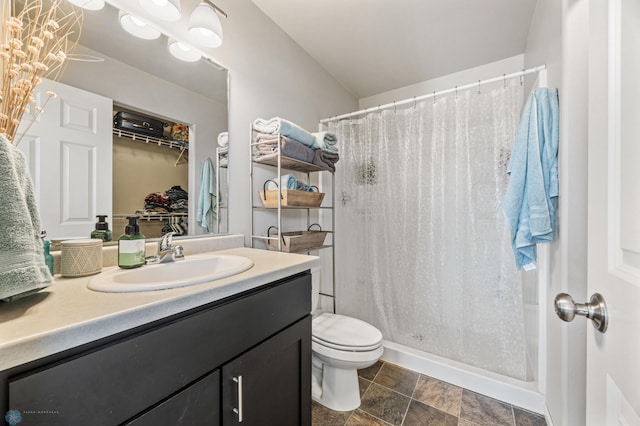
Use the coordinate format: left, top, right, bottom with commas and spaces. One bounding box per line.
125, 370, 220, 426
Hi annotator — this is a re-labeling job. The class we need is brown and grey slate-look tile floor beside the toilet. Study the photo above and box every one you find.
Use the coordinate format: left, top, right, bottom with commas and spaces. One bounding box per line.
312, 361, 546, 426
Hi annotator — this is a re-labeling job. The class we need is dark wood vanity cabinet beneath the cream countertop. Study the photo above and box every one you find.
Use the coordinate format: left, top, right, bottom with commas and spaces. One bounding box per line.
1, 272, 311, 426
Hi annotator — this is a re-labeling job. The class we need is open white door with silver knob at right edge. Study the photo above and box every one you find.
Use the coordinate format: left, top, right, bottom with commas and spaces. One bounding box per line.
580, 0, 640, 426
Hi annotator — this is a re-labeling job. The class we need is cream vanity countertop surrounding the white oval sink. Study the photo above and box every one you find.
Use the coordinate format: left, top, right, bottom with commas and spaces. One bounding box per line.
0, 238, 320, 371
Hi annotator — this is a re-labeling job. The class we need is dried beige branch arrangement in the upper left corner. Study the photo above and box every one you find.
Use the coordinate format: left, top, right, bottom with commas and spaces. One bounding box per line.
0, 0, 82, 145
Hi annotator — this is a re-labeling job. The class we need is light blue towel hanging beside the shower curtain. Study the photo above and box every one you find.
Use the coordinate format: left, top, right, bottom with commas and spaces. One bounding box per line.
502, 88, 559, 271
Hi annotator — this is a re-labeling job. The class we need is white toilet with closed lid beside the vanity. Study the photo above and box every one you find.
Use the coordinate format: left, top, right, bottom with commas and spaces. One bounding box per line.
311, 274, 383, 411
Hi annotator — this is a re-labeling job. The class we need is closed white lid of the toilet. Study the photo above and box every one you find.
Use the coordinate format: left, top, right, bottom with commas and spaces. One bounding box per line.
312, 313, 382, 350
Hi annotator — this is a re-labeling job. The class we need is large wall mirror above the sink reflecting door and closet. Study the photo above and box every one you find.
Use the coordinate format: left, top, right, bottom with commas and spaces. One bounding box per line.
20, 0, 229, 240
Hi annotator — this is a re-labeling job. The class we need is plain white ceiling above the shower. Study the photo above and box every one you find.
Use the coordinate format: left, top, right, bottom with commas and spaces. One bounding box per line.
253, 0, 537, 98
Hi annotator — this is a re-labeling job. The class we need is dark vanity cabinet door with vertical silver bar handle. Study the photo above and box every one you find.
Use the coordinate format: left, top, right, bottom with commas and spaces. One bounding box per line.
222, 316, 311, 426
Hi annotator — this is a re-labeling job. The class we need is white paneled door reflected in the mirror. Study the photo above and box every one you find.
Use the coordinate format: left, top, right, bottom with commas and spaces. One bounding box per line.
18, 80, 113, 239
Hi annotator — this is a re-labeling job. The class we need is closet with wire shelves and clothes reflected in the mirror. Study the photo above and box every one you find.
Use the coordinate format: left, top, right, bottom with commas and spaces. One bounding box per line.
113, 105, 189, 238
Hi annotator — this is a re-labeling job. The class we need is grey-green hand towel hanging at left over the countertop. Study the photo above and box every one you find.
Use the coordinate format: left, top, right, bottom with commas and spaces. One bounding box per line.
0, 135, 53, 301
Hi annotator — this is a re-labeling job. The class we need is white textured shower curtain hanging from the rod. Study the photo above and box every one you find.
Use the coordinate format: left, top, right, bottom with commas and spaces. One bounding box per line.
329, 82, 528, 380
